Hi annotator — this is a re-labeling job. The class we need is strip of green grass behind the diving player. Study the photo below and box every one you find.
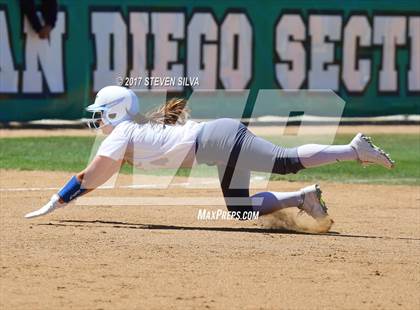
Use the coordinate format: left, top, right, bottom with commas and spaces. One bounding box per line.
0, 134, 420, 185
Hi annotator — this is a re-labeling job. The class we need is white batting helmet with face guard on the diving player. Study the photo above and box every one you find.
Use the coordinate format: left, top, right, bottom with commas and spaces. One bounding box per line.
86, 86, 139, 129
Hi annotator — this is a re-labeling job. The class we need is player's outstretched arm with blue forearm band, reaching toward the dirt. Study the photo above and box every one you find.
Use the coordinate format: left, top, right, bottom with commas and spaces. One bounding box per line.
25, 156, 122, 218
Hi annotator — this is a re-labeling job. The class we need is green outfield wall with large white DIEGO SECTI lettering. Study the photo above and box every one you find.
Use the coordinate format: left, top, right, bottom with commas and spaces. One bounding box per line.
0, 0, 420, 122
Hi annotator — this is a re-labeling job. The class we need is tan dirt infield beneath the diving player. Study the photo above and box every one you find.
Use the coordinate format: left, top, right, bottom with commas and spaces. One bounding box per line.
0, 170, 420, 309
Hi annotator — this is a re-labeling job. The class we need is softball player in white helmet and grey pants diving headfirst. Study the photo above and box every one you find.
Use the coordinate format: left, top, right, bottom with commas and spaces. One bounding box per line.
25, 86, 394, 219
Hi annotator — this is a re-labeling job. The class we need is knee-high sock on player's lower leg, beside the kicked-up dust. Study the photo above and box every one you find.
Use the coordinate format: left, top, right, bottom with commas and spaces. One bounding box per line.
251, 191, 304, 215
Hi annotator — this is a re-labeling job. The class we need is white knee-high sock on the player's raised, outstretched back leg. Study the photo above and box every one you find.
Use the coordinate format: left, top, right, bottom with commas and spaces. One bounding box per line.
297, 144, 357, 168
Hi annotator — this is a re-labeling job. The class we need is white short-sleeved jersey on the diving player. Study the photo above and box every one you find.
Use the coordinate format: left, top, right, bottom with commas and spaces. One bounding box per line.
97, 120, 204, 169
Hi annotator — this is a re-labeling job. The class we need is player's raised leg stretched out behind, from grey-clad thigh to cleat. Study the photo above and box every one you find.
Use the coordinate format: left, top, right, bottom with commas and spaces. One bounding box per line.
225, 121, 394, 174
